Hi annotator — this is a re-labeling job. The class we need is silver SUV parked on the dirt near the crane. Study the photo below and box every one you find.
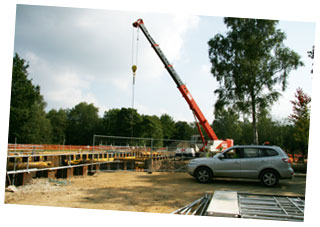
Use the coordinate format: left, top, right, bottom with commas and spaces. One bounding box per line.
187, 145, 294, 187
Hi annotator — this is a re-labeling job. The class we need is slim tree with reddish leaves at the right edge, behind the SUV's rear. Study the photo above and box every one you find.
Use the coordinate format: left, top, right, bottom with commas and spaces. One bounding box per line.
289, 88, 311, 161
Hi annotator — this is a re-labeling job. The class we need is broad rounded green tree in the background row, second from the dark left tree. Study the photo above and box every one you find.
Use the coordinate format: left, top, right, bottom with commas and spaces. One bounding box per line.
66, 102, 101, 145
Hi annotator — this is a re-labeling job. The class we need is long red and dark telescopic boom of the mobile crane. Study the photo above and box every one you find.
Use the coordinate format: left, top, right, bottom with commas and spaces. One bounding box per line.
133, 19, 231, 149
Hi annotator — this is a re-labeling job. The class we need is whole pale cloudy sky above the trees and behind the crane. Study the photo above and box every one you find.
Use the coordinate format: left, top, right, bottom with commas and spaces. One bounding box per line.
14, 5, 315, 122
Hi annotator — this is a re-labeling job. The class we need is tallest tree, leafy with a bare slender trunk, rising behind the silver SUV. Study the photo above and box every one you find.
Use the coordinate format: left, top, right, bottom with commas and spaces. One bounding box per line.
208, 18, 303, 144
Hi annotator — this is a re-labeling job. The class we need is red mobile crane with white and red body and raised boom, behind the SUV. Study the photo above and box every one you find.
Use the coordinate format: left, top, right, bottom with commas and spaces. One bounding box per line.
133, 19, 233, 151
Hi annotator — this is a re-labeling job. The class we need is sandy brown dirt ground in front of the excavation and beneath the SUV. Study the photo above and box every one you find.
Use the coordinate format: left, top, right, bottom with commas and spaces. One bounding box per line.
5, 171, 306, 213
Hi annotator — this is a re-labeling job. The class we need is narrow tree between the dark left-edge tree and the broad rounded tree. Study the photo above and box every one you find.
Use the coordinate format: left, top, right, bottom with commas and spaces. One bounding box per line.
47, 109, 67, 144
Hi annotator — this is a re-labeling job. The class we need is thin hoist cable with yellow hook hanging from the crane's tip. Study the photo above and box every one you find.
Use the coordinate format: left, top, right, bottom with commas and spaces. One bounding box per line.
131, 27, 139, 137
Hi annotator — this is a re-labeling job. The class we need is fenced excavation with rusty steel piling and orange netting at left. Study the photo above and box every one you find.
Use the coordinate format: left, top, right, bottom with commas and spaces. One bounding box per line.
6, 138, 186, 186
